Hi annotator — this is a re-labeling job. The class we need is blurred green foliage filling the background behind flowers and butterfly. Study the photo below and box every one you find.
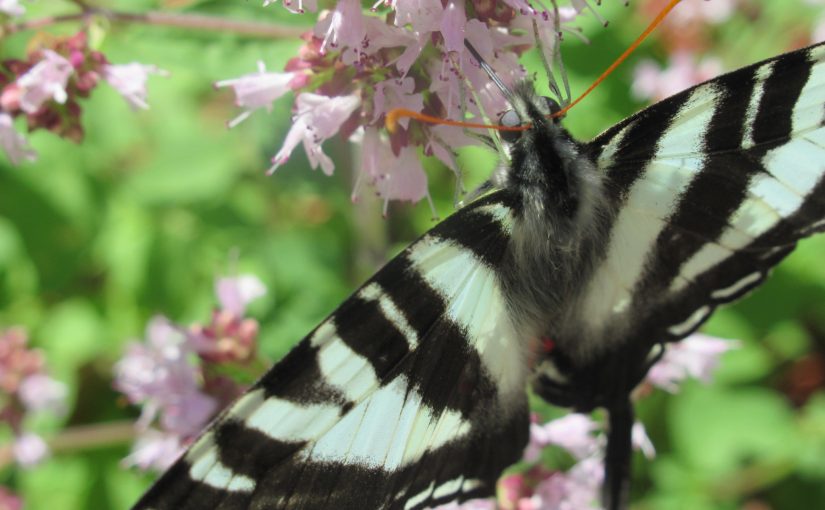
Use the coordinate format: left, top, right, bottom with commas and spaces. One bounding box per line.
0, 0, 825, 510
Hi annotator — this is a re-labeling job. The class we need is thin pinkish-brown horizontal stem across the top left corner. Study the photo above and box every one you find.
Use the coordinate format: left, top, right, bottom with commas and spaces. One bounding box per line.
0, 7, 308, 39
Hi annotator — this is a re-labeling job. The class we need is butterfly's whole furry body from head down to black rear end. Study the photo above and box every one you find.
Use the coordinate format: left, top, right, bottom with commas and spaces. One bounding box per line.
496, 87, 647, 409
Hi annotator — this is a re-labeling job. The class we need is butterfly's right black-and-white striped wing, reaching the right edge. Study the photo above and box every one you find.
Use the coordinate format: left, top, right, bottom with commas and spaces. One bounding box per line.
585, 44, 825, 343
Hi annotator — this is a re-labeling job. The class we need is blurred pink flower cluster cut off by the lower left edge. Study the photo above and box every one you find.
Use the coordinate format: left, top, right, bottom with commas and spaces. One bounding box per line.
0, 328, 67, 467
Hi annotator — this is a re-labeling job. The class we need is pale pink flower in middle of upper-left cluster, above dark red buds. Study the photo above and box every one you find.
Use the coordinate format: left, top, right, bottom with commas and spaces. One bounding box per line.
17, 50, 74, 113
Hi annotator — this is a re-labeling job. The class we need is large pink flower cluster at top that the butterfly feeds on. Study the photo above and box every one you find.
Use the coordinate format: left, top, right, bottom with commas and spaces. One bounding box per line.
216, 0, 588, 212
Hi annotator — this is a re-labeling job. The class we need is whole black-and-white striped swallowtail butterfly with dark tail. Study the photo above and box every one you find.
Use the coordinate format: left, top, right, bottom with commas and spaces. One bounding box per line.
130, 39, 825, 510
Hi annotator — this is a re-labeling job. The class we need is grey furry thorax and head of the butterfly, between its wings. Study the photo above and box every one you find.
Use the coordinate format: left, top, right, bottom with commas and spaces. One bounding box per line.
491, 89, 613, 361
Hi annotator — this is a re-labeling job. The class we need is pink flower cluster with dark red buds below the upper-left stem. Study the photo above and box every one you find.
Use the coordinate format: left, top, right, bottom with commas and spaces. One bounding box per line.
0, 32, 163, 164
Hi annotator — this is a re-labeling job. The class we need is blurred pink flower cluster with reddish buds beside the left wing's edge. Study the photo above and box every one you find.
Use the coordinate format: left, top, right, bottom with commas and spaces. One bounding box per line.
114, 275, 266, 470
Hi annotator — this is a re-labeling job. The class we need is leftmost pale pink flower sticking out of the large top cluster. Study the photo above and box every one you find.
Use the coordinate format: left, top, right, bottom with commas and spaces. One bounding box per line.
215, 61, 296, 128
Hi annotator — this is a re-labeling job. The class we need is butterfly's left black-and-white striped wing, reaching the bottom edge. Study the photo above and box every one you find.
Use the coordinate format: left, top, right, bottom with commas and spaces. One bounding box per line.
129, 193, 528, 510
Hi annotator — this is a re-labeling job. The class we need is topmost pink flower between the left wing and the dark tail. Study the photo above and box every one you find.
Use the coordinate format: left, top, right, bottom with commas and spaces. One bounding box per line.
524, 413, 599, 462
